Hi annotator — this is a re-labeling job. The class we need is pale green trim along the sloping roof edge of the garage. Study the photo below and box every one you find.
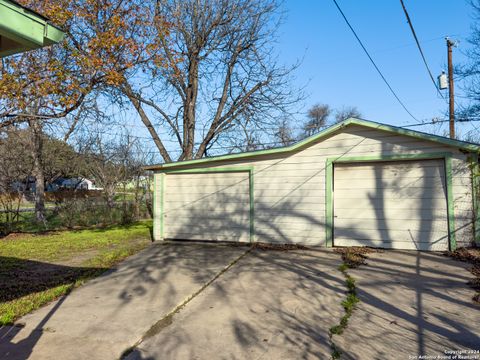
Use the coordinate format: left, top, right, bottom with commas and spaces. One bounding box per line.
145, 118, 480, 170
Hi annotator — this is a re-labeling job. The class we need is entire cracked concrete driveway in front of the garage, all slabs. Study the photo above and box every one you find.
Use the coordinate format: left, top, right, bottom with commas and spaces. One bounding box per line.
0, 243, 480, 360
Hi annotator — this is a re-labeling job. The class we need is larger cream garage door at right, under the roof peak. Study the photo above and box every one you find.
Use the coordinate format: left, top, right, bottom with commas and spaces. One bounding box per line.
333, 160, 448, 251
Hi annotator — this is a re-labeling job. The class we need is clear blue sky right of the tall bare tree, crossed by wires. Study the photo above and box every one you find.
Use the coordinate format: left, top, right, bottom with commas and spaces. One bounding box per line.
278, 0, 472, 134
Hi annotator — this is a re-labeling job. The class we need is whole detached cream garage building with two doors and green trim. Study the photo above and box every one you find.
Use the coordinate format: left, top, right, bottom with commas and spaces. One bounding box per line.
147, 119, 480, 250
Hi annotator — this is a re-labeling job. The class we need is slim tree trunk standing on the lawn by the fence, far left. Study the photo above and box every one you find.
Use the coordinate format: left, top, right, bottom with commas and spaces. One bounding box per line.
29, 119, 45, 223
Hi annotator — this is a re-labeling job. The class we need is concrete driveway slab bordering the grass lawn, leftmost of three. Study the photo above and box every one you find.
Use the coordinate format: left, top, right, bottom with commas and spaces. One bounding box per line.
0, 243, 251, 360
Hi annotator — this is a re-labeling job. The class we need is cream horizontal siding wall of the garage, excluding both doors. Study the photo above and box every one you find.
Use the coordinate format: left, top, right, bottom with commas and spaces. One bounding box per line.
156, 125, 473, 245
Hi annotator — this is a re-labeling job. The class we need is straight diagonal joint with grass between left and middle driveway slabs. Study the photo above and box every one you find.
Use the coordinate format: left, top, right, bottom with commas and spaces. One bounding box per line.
120, 246, 253, 359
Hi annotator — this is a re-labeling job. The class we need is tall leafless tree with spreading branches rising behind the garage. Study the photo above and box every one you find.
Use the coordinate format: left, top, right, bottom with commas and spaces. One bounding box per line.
122, 0, 298, 162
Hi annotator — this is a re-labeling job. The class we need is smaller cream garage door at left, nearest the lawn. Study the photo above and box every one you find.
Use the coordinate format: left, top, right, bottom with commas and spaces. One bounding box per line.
163, 172, 250, 242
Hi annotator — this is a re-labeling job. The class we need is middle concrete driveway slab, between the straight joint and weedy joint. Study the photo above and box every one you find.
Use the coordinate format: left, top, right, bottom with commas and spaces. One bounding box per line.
128, 250, 345, 360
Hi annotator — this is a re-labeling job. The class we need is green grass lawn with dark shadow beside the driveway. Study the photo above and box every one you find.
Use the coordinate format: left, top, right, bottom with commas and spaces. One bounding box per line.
0, 221, 152, 325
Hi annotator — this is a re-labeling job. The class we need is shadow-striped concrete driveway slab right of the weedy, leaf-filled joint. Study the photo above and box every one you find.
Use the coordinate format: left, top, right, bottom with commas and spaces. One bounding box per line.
334, 251, 480, 360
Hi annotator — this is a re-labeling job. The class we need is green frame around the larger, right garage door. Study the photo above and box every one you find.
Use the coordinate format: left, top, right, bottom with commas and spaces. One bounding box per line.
325, 152, 457, 251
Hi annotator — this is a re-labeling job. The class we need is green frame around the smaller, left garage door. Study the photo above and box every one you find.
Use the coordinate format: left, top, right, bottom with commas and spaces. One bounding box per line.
161, 166, 255, 242
